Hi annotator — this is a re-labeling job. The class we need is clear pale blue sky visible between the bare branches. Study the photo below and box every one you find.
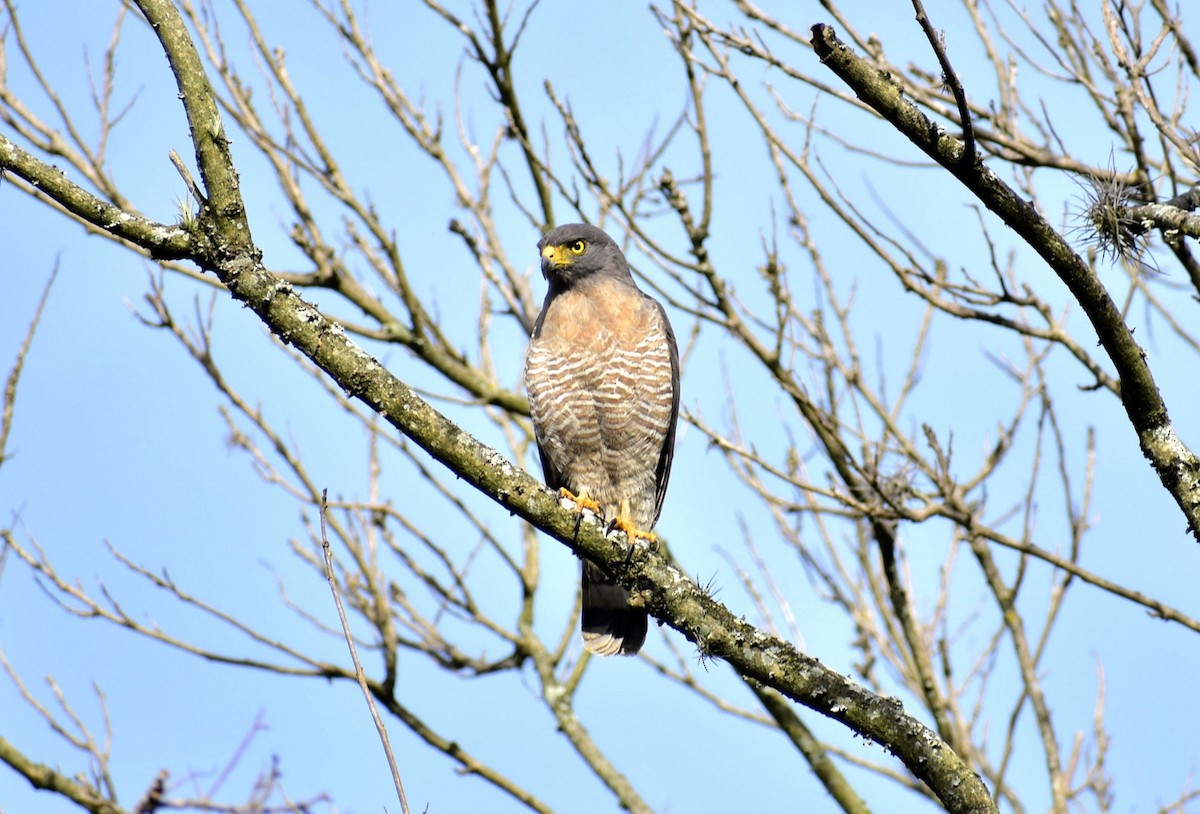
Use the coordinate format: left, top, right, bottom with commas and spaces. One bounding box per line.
0, 0, 1200, 813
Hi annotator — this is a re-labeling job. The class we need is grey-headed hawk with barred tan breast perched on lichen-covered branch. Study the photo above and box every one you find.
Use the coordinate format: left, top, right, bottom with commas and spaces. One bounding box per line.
526, 223, 679, 656
